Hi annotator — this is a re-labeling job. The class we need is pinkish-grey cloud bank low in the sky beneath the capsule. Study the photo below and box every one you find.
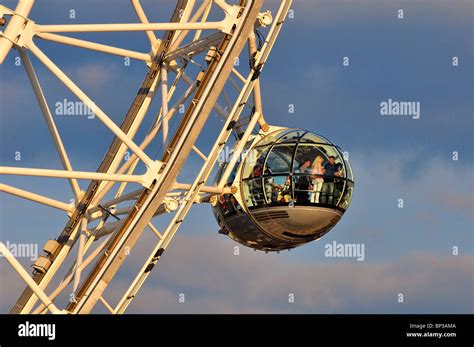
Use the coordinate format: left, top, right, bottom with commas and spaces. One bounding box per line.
116, 236, 474, 313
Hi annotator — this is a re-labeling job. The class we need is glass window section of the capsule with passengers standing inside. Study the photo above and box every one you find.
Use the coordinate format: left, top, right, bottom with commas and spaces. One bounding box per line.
242, 132, 353, 210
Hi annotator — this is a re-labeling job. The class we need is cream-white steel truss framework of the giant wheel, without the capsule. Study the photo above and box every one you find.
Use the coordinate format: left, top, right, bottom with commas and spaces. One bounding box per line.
0, 0, 291, 314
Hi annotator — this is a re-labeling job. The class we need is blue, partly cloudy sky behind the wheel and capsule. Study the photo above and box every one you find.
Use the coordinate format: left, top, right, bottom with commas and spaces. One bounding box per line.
0, 0, 474, 313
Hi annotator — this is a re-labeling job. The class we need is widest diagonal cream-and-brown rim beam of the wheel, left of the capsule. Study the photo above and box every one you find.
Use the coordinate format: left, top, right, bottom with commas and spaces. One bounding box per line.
68, 0, 262, 313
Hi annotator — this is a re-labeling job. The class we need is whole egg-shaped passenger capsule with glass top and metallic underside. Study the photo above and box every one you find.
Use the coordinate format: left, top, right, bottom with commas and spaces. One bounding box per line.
213, 128, 354, 251
